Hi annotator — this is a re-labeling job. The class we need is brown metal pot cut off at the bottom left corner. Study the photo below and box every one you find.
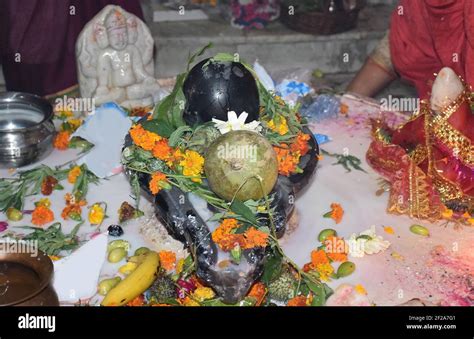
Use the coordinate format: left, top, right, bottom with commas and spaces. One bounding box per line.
0, 246, 59, 306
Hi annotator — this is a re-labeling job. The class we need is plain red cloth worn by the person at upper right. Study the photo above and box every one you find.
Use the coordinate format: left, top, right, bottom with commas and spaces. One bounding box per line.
390, 0, 474, 99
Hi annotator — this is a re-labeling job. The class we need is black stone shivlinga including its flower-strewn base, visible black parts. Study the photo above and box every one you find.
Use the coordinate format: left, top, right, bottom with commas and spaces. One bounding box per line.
125, 59, 319, 304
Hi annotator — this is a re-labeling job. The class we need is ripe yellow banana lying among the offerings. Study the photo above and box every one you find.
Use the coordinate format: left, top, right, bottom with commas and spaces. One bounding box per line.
101, 251, 160, 306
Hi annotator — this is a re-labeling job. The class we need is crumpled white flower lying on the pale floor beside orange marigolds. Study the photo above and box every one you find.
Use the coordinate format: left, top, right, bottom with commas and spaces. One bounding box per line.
348, 226, 390, 258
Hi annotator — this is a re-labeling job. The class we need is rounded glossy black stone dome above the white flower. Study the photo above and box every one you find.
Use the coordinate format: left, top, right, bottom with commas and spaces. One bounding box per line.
183, 59, 259, 125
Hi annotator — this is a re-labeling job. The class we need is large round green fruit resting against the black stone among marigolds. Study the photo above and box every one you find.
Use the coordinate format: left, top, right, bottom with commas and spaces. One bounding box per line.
204, 130, 278, 201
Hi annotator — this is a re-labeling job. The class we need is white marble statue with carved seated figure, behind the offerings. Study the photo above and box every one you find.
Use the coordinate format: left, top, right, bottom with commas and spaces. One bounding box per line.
76, 5, 165, 108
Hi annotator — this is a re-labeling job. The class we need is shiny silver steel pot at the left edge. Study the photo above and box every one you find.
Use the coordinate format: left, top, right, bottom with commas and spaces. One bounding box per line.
0, 92, 55, 167
